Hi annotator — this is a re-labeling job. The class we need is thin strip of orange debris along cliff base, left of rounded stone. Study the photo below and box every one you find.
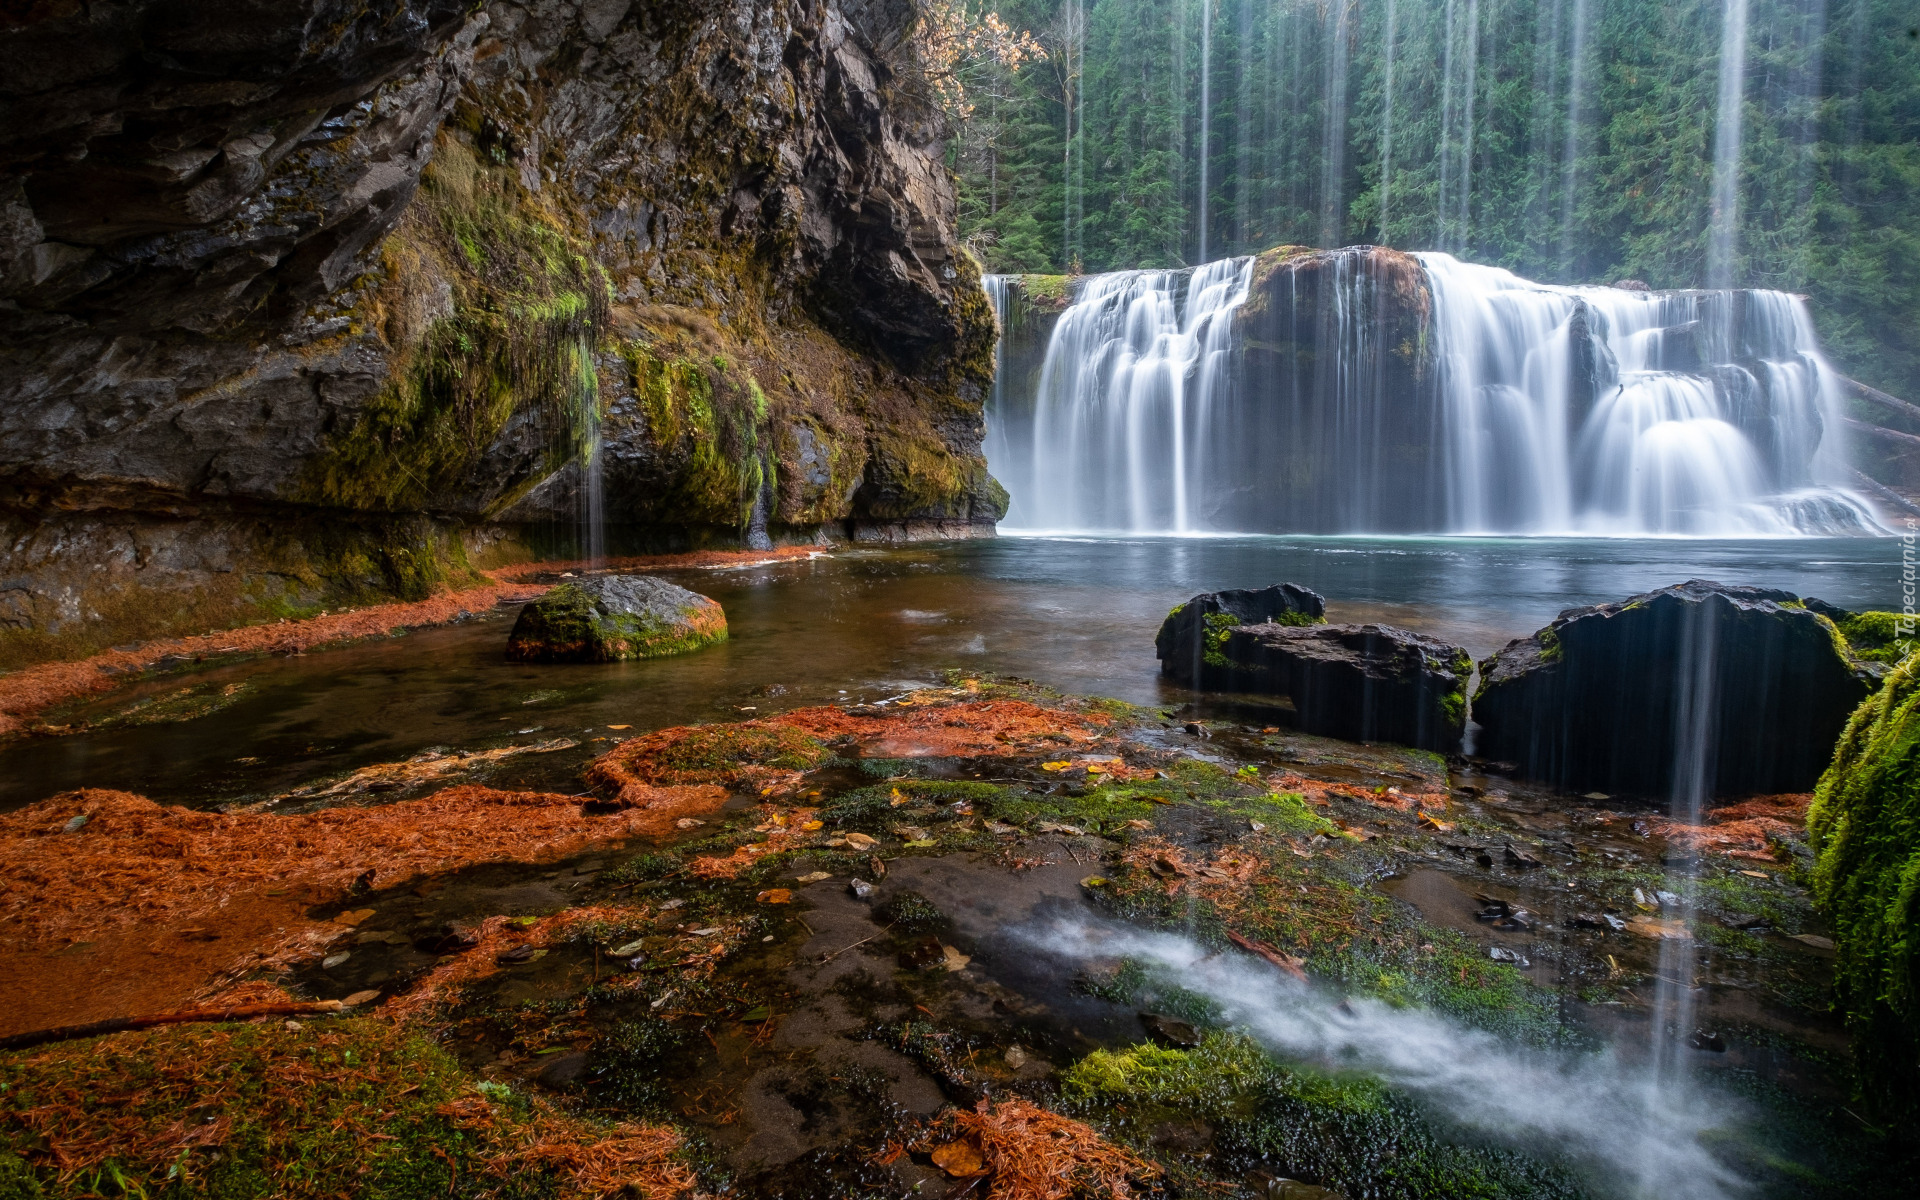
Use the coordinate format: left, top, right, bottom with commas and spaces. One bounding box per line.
0, 584, 545, 737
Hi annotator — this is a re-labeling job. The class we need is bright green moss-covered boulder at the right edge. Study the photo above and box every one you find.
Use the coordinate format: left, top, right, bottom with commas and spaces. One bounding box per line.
1807, 657, 1920, 1129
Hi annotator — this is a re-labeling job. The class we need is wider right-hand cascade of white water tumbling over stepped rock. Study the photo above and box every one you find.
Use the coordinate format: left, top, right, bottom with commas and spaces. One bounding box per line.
1417, 253, 1880, 536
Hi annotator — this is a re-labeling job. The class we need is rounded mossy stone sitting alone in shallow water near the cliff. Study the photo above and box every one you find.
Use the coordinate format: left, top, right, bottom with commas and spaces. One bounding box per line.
507, 574, 726, 662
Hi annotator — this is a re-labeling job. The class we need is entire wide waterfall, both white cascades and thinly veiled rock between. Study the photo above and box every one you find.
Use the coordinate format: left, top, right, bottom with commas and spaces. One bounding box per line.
987, 248, 1884, 538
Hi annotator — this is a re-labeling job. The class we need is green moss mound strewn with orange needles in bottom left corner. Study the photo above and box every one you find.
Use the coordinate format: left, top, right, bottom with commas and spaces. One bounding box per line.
0, 1018, 660, 1200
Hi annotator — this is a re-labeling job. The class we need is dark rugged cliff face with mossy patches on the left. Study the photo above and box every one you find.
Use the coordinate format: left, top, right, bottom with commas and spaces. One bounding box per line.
0, 0, 1004, 659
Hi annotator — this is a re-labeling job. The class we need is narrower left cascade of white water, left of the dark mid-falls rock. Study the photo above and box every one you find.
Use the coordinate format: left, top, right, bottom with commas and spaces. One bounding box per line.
989, 259, 1254, 534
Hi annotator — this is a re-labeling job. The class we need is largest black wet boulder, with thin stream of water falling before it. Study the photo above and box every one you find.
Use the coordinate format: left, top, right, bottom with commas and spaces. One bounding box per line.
1473, 580, 1885, 797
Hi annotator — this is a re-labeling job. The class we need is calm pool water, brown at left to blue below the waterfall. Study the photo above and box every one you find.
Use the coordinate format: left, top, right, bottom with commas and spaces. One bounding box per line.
0, 538, 1899, 804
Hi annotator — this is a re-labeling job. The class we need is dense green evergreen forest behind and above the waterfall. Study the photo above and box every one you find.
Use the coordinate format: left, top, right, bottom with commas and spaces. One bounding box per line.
954, 0, 1920, 396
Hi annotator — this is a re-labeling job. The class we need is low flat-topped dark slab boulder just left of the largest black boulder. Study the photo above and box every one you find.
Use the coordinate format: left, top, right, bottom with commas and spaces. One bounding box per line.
1219, 624, 1473, 751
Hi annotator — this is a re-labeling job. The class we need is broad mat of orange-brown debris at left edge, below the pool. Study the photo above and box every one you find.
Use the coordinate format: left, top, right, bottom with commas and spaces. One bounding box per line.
0, 785, 691, 1033
